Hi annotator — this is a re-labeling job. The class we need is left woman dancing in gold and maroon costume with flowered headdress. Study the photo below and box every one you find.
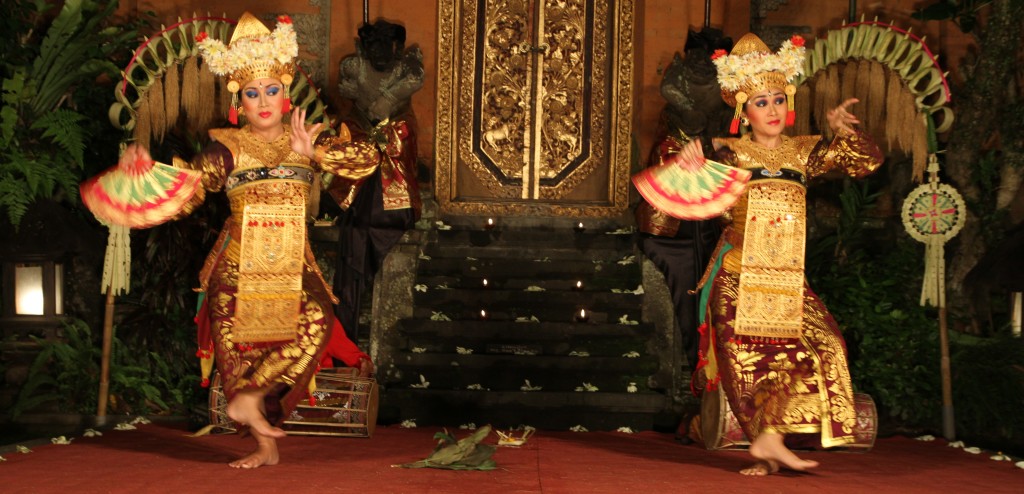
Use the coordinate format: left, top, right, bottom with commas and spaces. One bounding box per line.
121, 12, 389, 468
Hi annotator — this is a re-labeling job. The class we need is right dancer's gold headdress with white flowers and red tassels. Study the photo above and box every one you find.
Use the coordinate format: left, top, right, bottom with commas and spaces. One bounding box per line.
712, 33, 806, 133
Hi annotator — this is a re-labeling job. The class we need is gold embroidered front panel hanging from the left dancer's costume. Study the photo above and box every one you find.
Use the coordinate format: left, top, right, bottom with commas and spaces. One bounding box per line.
232, 204, 306, 342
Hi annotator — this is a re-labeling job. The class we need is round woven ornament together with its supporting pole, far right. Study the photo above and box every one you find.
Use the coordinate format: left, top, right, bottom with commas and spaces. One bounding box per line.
902, 154, 967, 441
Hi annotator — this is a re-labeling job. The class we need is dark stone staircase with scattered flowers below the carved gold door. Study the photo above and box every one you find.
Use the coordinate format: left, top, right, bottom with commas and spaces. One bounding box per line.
375, 221, 676, 430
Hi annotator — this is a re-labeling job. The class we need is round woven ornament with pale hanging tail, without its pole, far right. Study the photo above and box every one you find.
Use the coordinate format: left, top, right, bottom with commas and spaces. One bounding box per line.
902, 154, 967, 307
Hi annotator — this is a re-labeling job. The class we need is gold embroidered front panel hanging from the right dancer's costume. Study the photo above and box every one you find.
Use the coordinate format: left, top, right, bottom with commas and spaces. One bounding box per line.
735, 180, 807, 338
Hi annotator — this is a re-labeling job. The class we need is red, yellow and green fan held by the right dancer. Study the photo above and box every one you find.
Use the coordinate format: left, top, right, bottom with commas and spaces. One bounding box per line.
633, 159, 751, 220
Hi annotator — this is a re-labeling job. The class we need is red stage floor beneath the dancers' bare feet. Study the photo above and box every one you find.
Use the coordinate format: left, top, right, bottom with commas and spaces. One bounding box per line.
0, 424, 1024, 494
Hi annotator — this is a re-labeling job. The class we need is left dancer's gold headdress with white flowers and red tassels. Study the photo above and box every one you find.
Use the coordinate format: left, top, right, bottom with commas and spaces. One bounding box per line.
196, 12, 299, 124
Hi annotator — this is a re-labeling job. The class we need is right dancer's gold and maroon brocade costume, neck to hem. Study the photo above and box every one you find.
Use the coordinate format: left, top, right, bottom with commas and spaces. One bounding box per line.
700, 132, 882, 447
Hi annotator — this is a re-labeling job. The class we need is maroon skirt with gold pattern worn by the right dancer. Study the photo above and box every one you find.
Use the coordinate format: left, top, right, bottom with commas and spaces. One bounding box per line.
706, 267, 856, 448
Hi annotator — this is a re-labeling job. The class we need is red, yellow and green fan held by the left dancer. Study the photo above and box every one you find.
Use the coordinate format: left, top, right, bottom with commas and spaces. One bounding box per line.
81, 156, 203, 229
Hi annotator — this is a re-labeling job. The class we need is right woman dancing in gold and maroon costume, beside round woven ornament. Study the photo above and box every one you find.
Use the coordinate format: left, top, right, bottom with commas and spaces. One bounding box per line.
680, 34, 883, 476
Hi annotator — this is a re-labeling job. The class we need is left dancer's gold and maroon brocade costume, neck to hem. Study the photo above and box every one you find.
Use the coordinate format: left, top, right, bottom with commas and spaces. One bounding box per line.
184, 125, 380, 422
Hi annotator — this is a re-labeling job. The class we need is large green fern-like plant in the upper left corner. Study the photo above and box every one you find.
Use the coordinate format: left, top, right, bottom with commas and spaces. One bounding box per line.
0, 0, 138, 225
